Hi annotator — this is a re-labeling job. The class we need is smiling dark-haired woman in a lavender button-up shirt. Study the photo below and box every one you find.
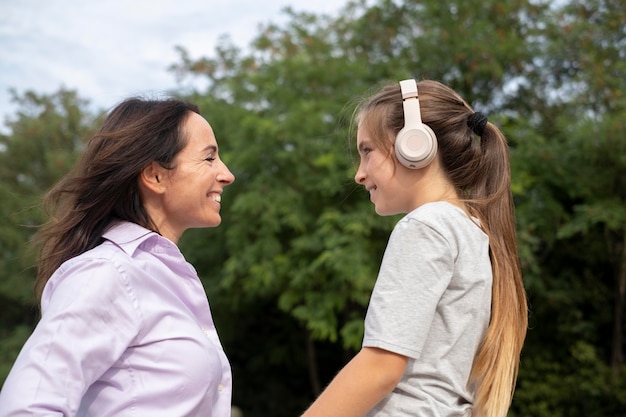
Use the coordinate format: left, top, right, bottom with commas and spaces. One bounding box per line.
0, 98, 234, 417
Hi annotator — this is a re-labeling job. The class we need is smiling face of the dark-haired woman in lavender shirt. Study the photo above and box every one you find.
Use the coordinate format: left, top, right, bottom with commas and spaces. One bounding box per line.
158, 112, 235, 242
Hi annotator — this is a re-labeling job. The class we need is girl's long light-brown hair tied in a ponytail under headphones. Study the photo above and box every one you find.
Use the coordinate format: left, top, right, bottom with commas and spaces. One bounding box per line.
357, 80, 528, 417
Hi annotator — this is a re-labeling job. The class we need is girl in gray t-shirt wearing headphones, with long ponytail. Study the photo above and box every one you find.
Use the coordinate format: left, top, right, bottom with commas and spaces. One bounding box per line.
304, 80, 527, 417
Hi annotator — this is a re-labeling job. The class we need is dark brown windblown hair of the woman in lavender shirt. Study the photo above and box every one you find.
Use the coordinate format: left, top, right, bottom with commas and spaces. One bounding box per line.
35, 98, 198, 299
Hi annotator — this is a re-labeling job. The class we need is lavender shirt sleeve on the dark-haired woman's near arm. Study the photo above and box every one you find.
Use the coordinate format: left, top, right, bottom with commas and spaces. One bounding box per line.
0, 259, 140, 416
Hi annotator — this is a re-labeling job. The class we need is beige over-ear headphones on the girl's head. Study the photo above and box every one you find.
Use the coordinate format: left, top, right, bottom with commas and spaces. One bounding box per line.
395, 80, 437, 169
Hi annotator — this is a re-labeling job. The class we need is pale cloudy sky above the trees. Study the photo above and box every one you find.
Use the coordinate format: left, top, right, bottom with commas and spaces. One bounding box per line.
0, 0, 347, 131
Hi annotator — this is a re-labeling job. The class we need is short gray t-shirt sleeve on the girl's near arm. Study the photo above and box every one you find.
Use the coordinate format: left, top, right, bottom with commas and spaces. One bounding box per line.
363, 219, 454, 359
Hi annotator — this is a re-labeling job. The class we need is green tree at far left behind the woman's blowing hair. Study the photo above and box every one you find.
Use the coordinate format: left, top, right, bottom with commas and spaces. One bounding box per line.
0, 89, 94, 380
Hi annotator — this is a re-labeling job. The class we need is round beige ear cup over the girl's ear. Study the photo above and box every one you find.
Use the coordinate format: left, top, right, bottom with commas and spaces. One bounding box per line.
395, 123, 437, 169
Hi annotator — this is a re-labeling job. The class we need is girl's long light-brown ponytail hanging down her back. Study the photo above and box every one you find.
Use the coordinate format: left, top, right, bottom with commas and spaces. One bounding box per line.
466, 123, 528, 417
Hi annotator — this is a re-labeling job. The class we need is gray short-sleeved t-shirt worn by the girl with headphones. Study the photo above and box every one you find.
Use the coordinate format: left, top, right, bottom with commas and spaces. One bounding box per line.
363, 202, 492, 417
